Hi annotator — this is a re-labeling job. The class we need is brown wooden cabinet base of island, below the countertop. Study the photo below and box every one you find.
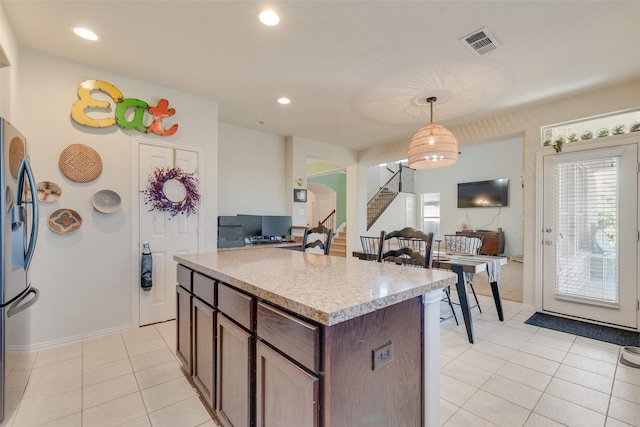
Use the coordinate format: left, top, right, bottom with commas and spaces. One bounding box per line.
177, 266, 423, 427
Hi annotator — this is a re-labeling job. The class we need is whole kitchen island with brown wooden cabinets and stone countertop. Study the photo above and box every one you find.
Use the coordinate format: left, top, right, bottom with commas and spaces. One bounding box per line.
174, 248, 456, 427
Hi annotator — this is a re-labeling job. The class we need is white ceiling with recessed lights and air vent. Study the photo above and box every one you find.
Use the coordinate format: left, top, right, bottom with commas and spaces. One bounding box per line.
2, 0, 640, 149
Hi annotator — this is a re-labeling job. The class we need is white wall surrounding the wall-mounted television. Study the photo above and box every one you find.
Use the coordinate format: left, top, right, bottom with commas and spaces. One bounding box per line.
415, 138, 523, 255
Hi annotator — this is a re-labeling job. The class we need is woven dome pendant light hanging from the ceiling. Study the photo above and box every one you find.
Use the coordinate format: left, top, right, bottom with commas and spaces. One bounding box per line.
409, 96, 458, 169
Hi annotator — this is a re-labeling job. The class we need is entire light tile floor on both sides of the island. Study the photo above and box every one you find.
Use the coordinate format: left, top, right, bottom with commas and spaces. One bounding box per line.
2, 293, 640, 427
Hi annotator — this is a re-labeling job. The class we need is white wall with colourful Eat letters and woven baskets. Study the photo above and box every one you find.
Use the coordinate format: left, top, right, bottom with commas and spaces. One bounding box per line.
12, 50, 218, 348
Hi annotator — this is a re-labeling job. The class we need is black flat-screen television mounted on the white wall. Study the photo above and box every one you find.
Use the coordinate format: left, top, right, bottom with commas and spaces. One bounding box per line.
458, 178, 509, 208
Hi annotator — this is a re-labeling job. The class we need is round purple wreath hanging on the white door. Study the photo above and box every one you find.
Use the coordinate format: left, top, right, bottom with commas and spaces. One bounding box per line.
141, 167, 200, 217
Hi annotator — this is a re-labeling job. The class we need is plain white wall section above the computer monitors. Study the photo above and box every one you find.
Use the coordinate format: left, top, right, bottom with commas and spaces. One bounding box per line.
218, 123, 286, 215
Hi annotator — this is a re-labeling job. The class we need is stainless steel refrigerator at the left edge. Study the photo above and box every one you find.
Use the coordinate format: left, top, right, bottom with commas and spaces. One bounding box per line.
0, 118, 39, 421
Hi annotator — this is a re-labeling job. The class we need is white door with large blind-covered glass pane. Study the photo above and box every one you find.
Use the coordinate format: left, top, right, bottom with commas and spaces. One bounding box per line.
542, 144, 638, 329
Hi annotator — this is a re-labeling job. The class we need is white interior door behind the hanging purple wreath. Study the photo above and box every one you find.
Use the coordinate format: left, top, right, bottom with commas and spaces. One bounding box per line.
138, 143, 198, 326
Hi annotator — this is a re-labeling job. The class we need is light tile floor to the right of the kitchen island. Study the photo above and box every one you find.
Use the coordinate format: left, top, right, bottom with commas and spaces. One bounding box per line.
440, 296, 640, 427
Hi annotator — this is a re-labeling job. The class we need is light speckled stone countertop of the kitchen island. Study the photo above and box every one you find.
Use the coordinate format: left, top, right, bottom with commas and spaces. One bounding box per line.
174, 248, 456, 326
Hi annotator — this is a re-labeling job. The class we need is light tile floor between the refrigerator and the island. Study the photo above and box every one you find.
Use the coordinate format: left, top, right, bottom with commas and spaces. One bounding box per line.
2, 321, 216, 427
